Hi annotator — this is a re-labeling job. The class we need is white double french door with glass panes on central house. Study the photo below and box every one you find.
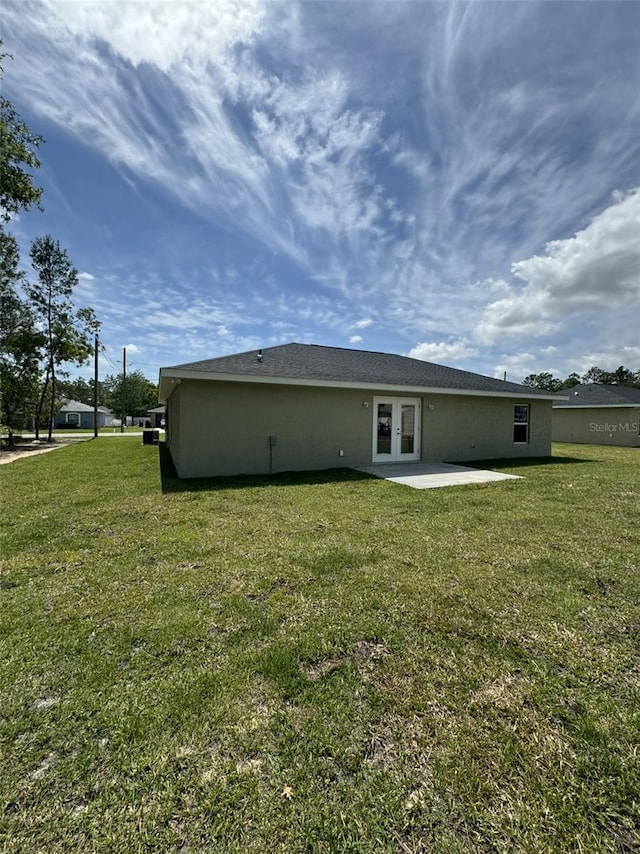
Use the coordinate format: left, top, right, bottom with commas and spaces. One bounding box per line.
373, 397, 421, 463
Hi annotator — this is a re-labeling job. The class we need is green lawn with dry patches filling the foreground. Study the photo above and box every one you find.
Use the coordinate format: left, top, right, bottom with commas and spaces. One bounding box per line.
0, 438, 640, 854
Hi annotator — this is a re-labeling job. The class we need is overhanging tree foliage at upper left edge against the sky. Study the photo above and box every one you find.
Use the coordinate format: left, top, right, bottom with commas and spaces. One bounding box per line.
0, 45, 42, 222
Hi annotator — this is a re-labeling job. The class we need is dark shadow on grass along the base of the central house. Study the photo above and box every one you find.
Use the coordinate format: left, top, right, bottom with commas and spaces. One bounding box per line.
158, 442, 377, 493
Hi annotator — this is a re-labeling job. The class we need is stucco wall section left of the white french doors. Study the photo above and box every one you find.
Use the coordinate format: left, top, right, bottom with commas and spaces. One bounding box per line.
168, 380, 372, 477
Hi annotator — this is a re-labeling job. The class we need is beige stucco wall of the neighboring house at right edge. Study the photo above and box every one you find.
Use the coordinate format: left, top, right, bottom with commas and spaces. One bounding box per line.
552, 406, 640, 448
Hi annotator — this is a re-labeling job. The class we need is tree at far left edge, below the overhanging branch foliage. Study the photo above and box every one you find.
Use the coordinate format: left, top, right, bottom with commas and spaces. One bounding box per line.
0, 229, 44, 444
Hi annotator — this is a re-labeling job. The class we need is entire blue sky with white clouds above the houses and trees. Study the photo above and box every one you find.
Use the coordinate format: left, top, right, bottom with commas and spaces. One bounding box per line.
2, 0, 640, 381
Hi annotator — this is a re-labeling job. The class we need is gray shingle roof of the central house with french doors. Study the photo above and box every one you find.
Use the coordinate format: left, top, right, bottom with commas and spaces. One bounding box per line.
162, 343, 549, 397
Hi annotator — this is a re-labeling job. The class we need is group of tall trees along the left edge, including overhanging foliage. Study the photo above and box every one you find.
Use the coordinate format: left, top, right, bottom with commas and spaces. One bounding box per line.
0, 47, 100, 443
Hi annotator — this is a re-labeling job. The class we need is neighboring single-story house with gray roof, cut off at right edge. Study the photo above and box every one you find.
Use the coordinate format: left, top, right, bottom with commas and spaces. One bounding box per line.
552, 383, 640, 448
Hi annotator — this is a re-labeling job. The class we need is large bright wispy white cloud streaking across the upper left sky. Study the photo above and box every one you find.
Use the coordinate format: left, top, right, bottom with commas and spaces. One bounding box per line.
7, 0, 390, 278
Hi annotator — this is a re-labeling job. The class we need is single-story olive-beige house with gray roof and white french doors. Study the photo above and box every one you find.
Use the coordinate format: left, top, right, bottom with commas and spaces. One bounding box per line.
159, 344, 555, 477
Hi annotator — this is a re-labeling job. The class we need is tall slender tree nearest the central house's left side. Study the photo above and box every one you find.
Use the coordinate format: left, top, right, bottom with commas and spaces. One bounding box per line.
26, 235, 100, 441
